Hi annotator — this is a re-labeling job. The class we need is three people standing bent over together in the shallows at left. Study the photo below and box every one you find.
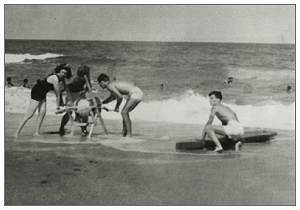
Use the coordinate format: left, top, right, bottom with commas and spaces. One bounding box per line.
14, 64, 143, 138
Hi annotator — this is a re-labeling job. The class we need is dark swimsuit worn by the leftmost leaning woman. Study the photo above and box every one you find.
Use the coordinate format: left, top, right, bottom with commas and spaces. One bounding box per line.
31, 77, 54, 101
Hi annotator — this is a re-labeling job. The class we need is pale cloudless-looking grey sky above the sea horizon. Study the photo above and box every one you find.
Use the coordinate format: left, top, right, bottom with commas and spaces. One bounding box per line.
4, 5, 295, 43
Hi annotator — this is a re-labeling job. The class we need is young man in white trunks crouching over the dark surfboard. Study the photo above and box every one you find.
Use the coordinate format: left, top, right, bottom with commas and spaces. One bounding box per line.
201, 91, 244, 152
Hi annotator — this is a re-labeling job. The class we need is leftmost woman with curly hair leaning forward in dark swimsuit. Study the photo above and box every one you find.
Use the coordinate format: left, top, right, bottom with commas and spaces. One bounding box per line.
14, 64, 72, 138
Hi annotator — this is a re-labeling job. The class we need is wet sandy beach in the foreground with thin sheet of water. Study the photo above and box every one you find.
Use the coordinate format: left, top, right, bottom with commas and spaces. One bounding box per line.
5, 113, 295, 205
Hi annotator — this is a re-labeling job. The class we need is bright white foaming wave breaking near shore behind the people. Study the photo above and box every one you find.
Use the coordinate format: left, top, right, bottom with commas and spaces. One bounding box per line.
5, 87, 295, 132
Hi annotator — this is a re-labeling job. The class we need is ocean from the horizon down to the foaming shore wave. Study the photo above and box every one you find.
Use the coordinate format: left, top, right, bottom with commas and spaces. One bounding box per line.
5, 40, 295, 129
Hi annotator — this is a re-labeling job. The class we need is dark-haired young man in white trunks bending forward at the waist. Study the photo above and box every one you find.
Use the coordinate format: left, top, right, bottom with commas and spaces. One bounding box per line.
98, 74, 143, 137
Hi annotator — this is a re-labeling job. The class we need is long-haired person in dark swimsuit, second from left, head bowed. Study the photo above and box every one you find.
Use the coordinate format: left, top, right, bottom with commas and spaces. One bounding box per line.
59, 65, 91, 136
